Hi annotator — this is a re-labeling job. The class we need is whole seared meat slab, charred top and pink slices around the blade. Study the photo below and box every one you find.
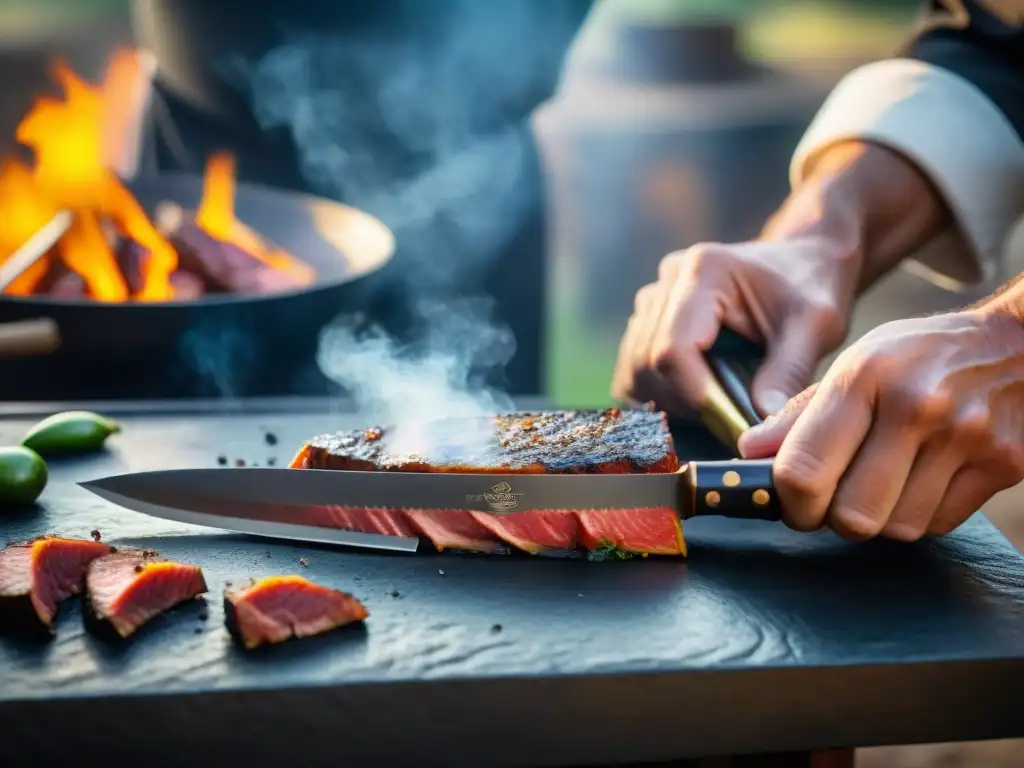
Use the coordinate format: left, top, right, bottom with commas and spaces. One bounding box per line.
289, 409, 686, 555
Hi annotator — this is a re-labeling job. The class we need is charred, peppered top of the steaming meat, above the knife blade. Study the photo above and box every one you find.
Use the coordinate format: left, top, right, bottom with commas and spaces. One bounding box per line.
290, 409, 679, 473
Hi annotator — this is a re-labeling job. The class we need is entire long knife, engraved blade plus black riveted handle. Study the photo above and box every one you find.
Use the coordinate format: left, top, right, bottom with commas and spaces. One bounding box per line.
79, 460, 780, 552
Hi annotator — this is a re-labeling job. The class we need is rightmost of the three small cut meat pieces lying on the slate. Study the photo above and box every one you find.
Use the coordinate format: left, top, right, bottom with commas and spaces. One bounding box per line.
224, 575, 370, 649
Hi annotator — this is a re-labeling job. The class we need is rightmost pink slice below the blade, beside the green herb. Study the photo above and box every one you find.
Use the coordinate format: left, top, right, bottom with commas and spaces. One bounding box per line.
577, 507, 686, 555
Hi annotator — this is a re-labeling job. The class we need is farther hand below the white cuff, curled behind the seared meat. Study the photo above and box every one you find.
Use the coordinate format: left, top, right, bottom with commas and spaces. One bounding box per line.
612, 236, 857, 421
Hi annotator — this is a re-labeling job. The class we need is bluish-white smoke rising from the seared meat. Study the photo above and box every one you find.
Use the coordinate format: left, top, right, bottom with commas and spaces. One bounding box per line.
207, 0, 586, 421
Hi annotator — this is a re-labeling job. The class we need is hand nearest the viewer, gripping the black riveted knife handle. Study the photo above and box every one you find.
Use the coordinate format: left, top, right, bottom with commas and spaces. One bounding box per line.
739, 308, 1024, 541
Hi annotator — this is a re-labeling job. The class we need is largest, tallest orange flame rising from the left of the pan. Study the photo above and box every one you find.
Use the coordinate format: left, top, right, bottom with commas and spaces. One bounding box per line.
15, 57, 177, 301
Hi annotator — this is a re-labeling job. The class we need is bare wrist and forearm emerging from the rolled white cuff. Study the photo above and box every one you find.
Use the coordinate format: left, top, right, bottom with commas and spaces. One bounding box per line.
761, 141, 951, 295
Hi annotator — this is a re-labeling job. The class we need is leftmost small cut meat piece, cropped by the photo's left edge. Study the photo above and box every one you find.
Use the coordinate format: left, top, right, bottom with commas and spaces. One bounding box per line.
0, 536, 113, 631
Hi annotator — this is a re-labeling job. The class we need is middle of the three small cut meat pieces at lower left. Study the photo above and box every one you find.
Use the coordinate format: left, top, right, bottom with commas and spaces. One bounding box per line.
85, 549, 207, 638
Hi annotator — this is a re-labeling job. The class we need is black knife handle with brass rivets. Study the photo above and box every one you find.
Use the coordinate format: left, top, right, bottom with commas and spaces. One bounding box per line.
683, 459, 782, 520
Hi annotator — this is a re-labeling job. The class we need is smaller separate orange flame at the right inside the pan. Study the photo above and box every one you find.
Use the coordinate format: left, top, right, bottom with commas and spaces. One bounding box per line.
196, 153, 314, 285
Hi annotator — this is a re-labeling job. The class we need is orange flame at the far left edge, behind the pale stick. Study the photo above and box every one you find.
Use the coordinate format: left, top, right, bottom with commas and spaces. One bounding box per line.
0, 160, 57, 296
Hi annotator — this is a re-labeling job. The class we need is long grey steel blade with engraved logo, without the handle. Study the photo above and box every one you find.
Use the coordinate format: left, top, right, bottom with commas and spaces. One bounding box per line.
82, 467, 688, 522
